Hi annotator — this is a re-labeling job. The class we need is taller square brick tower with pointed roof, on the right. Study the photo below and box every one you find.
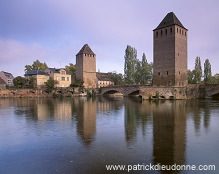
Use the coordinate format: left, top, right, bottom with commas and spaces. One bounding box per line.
153, 12, 188, 86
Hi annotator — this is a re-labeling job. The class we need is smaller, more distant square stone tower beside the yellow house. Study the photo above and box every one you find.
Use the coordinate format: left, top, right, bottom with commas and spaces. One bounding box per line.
76, 44, 97, 88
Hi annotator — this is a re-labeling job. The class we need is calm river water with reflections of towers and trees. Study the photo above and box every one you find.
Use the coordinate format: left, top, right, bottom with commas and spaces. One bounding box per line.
0, 97, 219, 174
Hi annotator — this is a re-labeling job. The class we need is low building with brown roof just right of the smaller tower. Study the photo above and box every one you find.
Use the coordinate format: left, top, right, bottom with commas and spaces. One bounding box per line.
96, 72, 114, 88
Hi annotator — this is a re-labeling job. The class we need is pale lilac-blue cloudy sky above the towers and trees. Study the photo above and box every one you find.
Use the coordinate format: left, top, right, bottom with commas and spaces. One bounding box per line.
0, 0, 219, 77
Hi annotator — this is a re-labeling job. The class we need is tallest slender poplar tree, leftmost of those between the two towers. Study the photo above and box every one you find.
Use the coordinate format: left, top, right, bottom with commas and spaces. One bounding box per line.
124, 45, 137, 84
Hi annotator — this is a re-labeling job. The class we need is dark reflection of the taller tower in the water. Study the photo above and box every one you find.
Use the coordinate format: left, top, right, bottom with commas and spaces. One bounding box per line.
153, 101, 186, 170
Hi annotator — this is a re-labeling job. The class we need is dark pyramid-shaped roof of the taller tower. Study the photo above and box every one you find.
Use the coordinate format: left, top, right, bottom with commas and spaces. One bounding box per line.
154, 12, 187, 30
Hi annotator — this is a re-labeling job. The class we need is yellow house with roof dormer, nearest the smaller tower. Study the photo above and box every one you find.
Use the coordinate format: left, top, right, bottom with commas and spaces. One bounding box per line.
44, 68, 71, 87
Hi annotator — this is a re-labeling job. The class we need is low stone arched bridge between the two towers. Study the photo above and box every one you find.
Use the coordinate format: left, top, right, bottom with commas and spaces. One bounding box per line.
100, 85, 146, 96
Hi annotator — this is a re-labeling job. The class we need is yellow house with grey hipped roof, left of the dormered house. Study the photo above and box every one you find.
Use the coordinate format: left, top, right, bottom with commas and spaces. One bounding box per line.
24, 69, 49, 87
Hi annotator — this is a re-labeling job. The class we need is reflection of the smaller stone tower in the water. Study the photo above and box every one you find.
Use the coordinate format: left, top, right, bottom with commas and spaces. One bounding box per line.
77, 100, 97, 145
